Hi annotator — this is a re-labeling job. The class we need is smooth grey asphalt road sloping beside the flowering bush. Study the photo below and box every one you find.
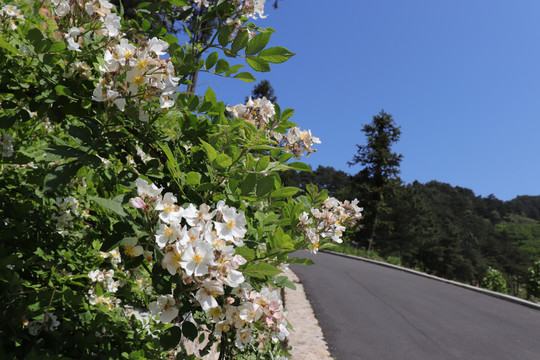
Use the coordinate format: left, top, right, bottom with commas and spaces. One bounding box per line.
291, 252, 540, 360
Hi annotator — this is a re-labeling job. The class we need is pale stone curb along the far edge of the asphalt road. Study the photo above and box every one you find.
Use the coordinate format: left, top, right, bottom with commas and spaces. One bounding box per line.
321, 250, 540, 310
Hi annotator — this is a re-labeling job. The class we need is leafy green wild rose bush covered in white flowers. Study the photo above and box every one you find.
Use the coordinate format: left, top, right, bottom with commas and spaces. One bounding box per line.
0, 0, 361, 359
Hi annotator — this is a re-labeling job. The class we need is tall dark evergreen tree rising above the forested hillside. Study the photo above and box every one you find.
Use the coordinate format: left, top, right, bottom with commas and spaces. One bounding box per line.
348, 110, 403, 250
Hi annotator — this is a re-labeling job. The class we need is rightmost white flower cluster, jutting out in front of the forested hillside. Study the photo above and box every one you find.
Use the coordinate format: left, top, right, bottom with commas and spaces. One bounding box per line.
299, 197, 363, 253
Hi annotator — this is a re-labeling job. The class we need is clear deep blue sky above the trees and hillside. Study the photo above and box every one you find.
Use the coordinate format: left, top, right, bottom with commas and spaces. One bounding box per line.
197, 0, 540, 200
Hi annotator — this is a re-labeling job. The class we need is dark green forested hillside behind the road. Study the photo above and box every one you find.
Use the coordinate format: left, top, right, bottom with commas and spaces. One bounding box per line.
282, 166, 540, 294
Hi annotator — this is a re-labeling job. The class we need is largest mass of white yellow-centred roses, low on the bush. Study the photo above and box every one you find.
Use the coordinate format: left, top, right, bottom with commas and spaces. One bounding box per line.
130, 178, 288, 348
